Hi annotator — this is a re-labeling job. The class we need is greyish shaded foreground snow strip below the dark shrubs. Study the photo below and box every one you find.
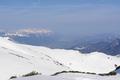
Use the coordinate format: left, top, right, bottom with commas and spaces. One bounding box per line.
13, 74, 120, 80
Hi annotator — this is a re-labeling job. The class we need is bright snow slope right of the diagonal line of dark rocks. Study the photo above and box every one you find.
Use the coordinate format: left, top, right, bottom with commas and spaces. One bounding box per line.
42, 50, 120, 73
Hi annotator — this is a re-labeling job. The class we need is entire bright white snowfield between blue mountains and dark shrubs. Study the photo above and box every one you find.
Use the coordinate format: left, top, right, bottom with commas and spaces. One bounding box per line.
0, 37, 120, 80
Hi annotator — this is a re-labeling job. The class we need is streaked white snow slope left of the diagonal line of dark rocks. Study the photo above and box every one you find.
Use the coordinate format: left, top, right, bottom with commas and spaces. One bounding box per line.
0, 38, 68, 80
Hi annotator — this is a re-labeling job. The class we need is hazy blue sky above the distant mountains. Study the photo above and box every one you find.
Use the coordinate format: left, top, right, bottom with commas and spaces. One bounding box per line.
0, 0, 120, 36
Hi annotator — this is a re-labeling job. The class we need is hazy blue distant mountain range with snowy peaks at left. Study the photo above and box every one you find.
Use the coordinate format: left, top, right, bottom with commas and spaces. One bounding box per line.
0, 29, 120, 55
